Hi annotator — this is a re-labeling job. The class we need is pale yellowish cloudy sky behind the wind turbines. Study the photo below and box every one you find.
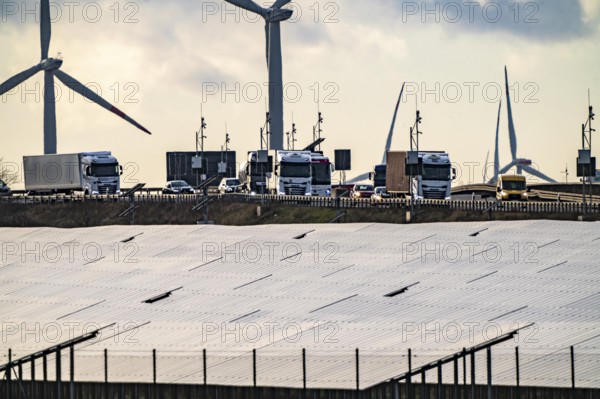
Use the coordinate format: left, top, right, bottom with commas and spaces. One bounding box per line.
0, 0, 600, 189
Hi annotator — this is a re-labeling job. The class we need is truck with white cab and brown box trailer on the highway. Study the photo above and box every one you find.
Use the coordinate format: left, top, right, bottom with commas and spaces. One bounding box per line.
385, 151, 456, 200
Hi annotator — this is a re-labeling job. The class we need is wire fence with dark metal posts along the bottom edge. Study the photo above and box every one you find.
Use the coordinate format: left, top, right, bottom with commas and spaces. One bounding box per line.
0, 347, 600, 398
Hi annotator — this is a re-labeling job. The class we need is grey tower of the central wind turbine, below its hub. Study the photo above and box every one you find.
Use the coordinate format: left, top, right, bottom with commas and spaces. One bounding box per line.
269, 22, 283, 150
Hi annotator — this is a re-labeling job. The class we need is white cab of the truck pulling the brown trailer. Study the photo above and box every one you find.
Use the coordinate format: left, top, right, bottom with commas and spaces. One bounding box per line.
412, 151, 456, 200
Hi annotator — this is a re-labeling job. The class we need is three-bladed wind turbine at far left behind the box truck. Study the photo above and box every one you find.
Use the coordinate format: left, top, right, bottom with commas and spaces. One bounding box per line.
0, 0, 151, 154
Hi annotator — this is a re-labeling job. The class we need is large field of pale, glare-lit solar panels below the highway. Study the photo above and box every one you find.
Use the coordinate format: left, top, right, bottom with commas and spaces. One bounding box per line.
0, 221, 600, 388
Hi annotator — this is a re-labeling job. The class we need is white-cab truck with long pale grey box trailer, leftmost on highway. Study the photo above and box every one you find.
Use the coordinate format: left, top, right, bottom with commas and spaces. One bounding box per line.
23, 151, 123, 195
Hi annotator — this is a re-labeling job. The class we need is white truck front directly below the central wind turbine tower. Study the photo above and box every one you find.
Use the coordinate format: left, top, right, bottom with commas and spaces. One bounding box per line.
275, 150, 312, 195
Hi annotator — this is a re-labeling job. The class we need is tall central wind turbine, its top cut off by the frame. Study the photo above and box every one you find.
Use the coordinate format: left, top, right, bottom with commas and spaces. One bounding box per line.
225, 0, 293, 150
